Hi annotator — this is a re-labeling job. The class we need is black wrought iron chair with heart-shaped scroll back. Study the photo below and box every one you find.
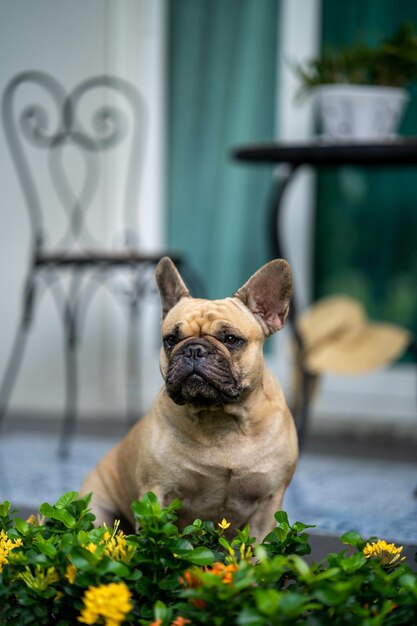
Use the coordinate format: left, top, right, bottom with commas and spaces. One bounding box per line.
0, 71, 181, 455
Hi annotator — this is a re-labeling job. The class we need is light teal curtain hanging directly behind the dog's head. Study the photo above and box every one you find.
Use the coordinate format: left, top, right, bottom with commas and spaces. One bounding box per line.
167, 0, 279, 298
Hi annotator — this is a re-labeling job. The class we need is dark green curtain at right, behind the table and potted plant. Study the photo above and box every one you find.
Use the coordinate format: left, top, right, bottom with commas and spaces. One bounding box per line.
314, 0, 417, 332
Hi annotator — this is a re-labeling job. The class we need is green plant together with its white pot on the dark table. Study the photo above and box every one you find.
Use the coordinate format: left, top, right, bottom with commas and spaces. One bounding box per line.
295, 23, 417, 141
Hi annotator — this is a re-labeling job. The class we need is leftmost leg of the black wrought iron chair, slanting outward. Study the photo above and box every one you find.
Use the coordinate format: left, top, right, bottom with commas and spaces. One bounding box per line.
0, 273, 35, 427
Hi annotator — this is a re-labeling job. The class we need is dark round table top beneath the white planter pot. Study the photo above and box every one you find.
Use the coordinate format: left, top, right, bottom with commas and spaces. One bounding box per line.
232, 137, 417, 167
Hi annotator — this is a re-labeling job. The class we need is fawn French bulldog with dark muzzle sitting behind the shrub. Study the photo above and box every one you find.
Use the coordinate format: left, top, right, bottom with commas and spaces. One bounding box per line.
81, 257, 298, 540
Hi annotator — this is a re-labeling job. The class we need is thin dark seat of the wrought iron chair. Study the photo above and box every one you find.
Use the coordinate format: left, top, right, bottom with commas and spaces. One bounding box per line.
34, 250, 180, 266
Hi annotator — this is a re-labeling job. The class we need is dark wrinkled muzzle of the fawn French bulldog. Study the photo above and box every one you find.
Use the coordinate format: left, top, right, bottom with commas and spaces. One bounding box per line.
165, 339, 242, 406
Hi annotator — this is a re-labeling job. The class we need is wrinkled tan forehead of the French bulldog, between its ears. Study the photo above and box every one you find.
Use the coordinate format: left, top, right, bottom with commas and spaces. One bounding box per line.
163, 298, 262, 338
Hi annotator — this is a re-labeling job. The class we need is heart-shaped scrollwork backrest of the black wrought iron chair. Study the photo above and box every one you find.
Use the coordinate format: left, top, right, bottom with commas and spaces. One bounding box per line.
2, 71, 147, 254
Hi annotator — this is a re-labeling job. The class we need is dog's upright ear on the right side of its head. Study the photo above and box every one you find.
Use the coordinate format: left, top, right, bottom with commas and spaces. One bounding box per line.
234, 259, 292, 336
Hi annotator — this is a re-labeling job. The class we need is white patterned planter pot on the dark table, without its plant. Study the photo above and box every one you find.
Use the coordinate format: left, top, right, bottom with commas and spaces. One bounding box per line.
313, 85, 409, 141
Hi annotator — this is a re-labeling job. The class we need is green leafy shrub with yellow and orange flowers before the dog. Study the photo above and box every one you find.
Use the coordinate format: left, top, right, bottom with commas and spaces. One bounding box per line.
0, 492, 417, 626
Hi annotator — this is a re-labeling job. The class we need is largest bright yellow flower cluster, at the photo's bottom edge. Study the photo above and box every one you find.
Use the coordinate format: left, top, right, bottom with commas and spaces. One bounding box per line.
77, 583, 133, 626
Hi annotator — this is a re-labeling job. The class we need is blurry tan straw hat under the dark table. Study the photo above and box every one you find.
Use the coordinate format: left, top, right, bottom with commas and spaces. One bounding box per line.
296, 295, 412, 374
